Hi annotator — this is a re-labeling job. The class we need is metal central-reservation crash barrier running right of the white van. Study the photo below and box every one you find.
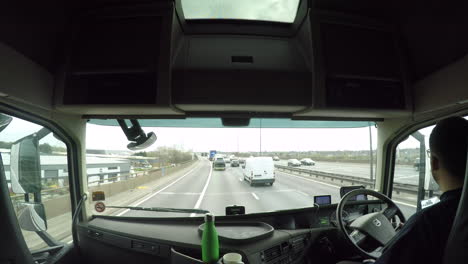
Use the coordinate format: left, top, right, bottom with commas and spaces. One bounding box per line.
275, 165, 440, 195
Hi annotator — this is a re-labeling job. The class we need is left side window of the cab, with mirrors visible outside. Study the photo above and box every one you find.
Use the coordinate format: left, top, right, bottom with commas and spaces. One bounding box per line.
0, 114, 72, 251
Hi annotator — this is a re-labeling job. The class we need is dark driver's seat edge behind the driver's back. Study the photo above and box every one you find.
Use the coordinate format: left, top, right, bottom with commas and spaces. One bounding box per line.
444, 144, 468, 264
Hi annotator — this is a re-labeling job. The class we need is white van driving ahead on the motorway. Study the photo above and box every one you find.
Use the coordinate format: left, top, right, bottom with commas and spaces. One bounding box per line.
242, 157, 275, 186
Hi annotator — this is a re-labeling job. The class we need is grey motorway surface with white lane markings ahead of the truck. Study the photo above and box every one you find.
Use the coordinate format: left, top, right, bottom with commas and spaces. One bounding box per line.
119, 159, 416, 217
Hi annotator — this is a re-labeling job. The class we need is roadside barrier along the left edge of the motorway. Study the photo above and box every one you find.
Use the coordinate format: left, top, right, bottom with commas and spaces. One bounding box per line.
10, 160, 196, 218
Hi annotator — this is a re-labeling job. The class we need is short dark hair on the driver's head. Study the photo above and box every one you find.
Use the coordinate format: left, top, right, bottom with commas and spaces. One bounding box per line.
429, 116, 468, 179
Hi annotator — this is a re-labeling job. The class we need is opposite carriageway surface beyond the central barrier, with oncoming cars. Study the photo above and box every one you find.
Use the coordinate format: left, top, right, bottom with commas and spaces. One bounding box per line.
275, 160, 419, 185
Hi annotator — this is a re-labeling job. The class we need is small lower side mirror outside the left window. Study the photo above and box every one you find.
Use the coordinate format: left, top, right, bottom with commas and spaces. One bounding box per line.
18, 203, 47, 232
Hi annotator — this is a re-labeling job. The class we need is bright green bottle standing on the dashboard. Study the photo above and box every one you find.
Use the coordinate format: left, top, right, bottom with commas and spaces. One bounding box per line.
202, 214, 219, 264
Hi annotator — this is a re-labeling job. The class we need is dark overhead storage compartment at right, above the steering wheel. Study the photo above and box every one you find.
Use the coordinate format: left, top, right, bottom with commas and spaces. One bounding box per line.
295, 10, 411, 117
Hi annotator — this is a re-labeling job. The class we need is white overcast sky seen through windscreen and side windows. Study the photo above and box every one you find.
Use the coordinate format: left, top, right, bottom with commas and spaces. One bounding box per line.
0, 118, 464, 152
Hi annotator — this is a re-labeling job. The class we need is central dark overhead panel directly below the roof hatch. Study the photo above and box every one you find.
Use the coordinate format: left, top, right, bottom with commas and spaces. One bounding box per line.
172, 35, 312, 111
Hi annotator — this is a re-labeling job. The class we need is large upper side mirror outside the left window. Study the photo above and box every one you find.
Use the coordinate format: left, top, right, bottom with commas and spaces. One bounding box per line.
10, 134, 42, 194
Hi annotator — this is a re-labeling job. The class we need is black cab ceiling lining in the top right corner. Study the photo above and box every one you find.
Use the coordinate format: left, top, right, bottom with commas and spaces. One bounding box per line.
311, 0, 468, 81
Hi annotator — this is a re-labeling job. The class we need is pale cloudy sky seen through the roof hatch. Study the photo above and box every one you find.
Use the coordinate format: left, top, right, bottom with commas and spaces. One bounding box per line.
182, 0, 299, 23
